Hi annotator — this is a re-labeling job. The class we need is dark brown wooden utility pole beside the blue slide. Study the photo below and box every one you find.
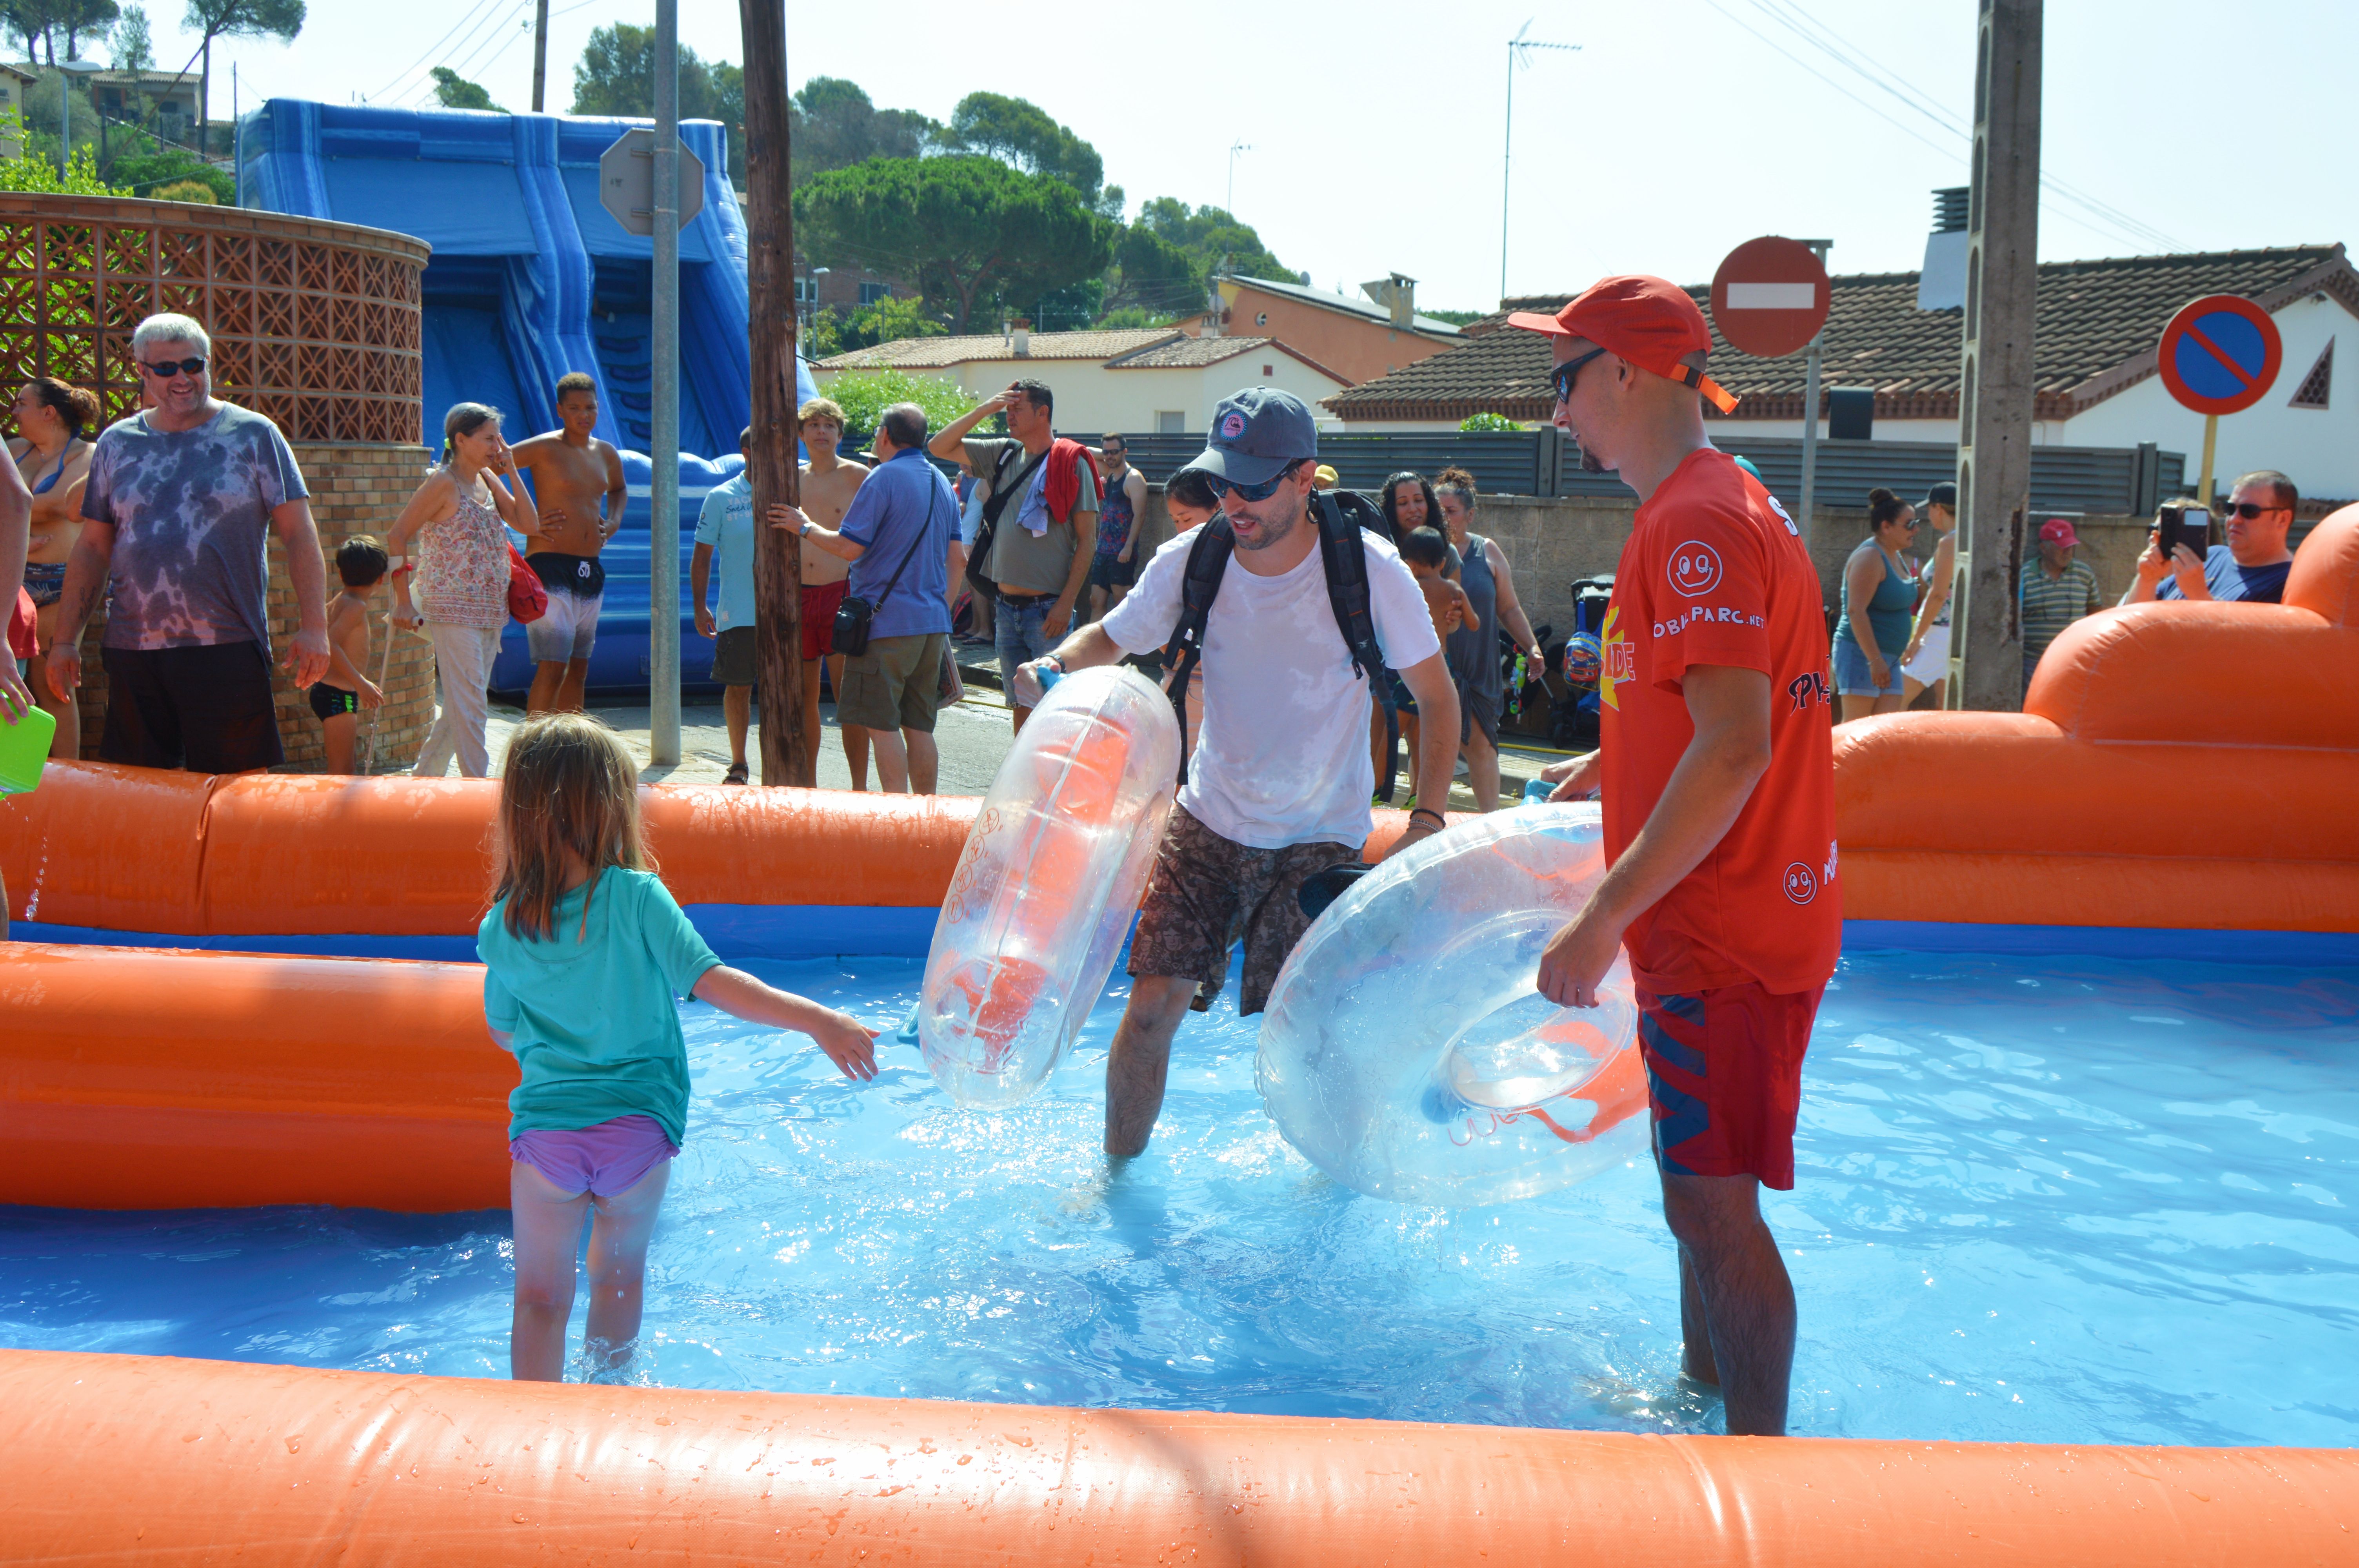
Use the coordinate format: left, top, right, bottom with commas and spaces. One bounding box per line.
738, 0, 819, 790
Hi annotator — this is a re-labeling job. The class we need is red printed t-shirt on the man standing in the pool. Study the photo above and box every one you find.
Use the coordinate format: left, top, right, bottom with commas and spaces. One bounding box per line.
1597, 448, 1842, 993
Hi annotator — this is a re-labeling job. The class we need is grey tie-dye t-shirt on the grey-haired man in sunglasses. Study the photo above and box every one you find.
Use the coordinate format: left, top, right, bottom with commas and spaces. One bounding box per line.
83, 403, 309, 653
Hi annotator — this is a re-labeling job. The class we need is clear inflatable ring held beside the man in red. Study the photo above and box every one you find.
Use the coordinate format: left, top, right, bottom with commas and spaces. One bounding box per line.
1258, 802, 1649, 1207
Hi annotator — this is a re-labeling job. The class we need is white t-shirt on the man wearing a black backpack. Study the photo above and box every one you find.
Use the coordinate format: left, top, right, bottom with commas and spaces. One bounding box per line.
1104, 523, 1441, 849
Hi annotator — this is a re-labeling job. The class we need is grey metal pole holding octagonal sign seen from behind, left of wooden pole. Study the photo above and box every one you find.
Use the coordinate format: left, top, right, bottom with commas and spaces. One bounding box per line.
646, 0, 680, 769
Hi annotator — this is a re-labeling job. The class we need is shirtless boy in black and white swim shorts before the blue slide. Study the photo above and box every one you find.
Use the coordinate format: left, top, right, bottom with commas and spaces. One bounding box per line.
512, 370, 630, 712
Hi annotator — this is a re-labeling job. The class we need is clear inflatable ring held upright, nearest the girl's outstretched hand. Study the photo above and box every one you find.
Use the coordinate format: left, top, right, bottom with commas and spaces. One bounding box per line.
915, 667, 1180, 1108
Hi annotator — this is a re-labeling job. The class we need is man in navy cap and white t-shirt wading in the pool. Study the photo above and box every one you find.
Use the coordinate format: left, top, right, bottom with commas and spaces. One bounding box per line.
1017, 387, 1458, 1158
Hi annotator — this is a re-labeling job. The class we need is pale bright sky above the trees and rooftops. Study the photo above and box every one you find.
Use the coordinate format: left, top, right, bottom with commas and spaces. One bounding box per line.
166, 0, 2359, 309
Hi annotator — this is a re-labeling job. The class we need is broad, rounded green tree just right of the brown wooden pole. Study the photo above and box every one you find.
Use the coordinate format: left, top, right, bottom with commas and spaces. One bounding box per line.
795, 156, 1114, 332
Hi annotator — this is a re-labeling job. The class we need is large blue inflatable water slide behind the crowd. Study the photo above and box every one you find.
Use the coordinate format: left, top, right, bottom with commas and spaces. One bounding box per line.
238, 99, 816, 695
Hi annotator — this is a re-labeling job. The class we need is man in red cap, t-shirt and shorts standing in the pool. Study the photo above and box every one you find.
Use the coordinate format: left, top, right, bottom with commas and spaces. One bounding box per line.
1507, 278, 1842, 1436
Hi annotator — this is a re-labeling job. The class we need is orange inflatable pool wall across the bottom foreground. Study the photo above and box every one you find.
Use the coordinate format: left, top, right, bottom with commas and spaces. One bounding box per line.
0, 1351, 2359, 1568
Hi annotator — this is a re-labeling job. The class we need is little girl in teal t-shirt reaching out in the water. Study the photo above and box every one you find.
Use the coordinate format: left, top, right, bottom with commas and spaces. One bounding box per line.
476, 712, 878, 1382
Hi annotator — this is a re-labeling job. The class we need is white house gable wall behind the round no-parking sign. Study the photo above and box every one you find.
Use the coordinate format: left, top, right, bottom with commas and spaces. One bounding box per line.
2050, 295, 2359, 500
